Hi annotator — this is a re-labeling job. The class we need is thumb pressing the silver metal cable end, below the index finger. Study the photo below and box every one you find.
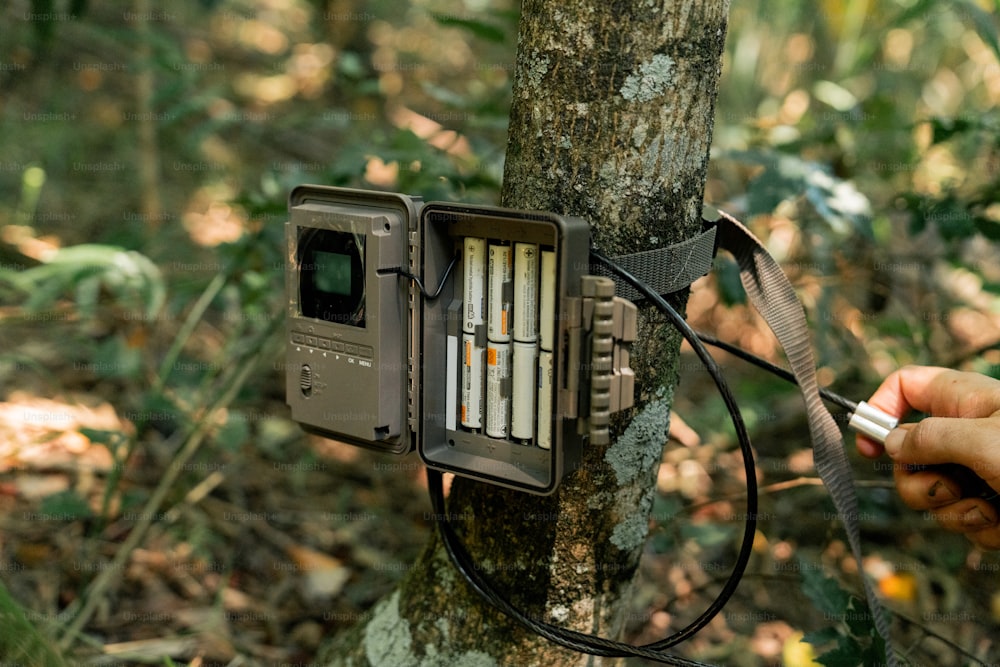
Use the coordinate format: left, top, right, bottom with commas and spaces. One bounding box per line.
885, 417, 1000, 491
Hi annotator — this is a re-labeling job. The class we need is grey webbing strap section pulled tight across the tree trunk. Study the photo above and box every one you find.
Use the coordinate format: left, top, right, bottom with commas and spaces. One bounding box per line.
591, 226, 716, 302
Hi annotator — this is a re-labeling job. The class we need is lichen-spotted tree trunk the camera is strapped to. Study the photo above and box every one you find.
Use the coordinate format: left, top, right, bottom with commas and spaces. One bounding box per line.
325, 0, 728, 667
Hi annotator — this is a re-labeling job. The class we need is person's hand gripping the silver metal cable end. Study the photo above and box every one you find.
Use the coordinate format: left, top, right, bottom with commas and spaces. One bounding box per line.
857, 366, 1000, 549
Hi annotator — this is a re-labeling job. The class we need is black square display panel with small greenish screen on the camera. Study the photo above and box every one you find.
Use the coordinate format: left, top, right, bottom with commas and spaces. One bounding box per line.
299, 227, 365, 327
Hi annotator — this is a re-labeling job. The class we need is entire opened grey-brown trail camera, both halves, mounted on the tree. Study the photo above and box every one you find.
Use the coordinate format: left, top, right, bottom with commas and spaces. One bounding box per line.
285, 185, 631, 495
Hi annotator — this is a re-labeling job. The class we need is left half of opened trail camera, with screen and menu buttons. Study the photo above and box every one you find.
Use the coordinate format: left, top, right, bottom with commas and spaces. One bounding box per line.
285, 185, 420, 454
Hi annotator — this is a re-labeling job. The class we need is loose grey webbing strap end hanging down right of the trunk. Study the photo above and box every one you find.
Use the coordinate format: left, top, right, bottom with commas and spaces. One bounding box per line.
716, 211, 898, 666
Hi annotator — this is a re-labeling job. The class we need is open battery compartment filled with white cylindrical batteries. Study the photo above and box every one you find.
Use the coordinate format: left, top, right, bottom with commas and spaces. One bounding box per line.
411, 204, 589, 494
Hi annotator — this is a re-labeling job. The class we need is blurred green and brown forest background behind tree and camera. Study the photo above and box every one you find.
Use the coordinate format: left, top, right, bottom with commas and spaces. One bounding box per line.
0, 0, 1000, 665
